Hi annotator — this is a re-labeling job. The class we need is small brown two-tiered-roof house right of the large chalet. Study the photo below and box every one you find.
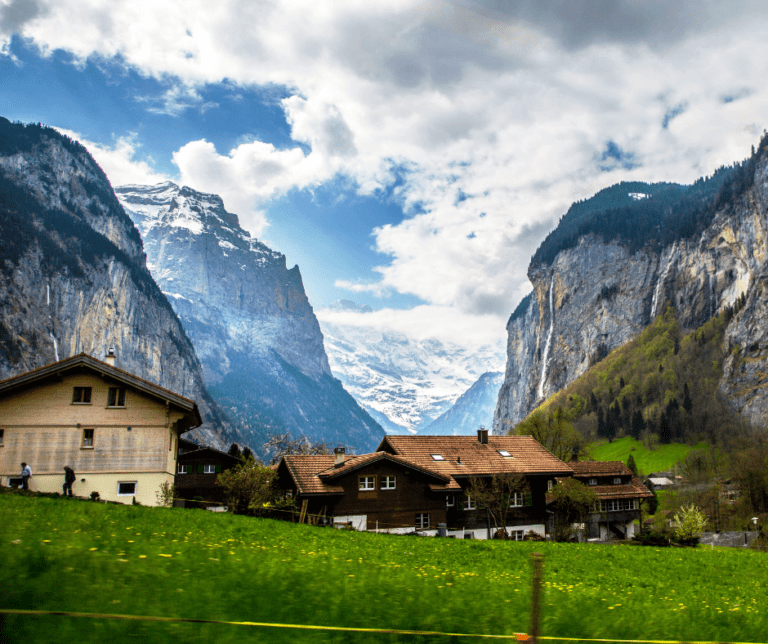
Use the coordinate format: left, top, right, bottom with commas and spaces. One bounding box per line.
569, 461, 653, 540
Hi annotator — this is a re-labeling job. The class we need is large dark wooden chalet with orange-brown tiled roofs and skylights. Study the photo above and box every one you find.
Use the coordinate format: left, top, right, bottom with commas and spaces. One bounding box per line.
277, 429, 572, 539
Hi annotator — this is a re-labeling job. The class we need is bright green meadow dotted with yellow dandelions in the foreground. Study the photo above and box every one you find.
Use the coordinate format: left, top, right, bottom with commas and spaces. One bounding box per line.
0, 493, 768, 644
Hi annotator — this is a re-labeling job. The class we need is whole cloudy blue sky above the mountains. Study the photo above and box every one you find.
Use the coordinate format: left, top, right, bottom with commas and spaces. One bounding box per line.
0, 0, 768, 352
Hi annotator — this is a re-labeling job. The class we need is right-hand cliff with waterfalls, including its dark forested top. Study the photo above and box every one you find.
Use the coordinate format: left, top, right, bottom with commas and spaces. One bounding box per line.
494, 137, 768, 433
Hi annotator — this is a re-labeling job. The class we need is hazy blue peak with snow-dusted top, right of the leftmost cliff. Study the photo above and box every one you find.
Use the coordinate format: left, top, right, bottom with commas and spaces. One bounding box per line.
116, 183, 384, 451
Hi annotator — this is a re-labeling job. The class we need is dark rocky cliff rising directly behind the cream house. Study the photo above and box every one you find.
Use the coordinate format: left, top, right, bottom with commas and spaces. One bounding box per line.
0, 119, 230, 446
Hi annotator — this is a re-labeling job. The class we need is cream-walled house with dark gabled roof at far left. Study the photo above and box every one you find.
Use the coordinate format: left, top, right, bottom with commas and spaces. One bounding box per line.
0, 350, 202, 505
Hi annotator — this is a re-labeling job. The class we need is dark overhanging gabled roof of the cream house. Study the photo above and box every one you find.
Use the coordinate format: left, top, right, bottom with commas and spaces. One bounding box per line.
0, 353, 203, 431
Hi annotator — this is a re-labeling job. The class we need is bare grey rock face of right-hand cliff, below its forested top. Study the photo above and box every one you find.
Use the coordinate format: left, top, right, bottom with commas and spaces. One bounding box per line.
494, 139, 768, 433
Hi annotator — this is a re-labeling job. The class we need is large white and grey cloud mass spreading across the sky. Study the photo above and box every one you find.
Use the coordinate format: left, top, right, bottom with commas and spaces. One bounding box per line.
8, 0, 768, 334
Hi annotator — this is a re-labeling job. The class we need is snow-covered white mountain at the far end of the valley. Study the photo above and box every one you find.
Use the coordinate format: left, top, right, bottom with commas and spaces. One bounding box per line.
318, 300, 504, 433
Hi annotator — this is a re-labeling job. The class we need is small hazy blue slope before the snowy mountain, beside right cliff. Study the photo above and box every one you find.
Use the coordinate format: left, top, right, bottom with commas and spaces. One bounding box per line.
423, 371, 504, 436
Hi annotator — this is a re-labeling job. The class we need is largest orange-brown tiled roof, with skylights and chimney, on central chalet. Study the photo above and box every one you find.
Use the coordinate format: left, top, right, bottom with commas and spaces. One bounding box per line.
379, 436, 572, 478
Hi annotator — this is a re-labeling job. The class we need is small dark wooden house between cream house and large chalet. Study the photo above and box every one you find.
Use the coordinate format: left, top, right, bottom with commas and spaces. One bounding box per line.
174, 439, 242, 510
